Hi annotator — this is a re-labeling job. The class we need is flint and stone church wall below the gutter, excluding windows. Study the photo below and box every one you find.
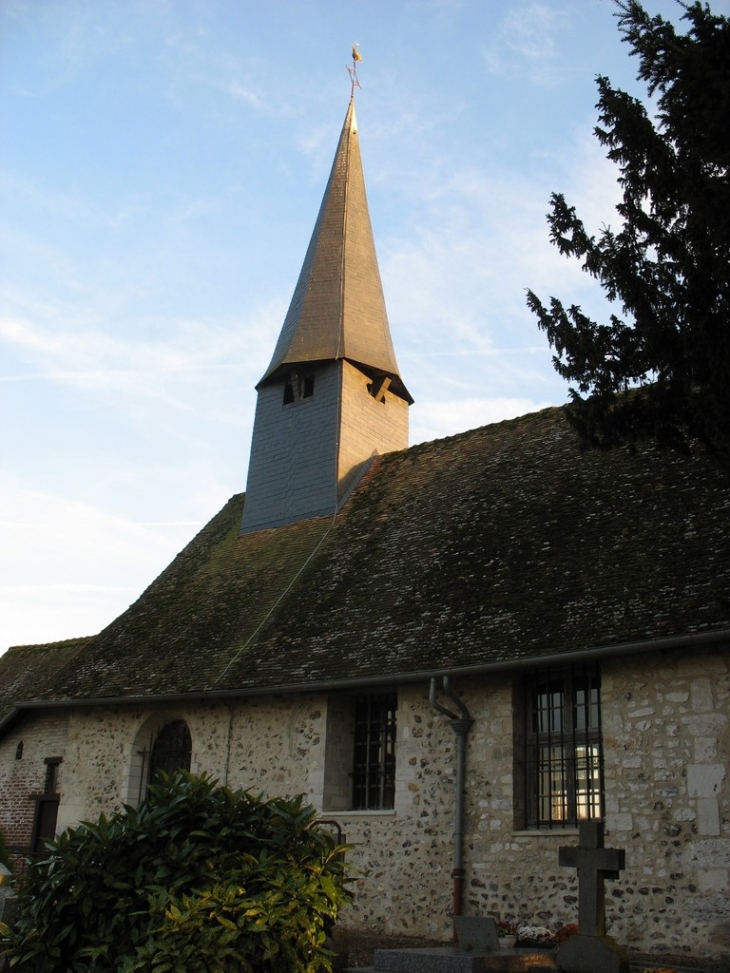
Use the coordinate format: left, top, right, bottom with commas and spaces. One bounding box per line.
0, 652, 730, 959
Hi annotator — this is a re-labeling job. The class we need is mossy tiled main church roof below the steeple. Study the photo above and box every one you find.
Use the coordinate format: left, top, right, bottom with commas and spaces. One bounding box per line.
0, 409, 730, 720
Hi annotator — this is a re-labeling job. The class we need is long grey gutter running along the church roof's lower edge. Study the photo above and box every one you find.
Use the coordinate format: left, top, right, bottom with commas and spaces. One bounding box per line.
0, 628, 730, 735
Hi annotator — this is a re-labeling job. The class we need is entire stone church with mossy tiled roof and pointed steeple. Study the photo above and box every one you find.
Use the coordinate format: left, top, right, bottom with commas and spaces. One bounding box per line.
0, 93, 730, 963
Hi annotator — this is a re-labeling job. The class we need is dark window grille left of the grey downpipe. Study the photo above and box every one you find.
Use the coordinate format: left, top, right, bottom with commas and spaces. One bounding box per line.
352, 693, 398, 810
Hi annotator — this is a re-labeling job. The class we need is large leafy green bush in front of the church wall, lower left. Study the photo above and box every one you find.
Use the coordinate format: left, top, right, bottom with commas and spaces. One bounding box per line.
0, 772, 347, 973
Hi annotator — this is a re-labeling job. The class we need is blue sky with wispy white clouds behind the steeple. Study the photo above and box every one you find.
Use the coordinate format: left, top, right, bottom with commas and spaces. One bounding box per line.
0, 0, 730, 652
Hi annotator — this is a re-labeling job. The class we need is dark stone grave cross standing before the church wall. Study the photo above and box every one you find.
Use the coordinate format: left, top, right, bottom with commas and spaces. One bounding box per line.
558, 821, 626, 936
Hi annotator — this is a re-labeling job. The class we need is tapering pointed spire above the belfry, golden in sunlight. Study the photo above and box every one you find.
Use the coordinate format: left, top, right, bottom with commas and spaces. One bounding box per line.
257, 98, 413, 402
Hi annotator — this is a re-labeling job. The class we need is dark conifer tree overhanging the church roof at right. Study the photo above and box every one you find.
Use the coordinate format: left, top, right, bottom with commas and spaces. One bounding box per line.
528, 0, 730, 465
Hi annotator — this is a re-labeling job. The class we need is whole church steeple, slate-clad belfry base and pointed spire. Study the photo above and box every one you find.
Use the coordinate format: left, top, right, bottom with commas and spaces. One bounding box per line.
242, 98, 406, 532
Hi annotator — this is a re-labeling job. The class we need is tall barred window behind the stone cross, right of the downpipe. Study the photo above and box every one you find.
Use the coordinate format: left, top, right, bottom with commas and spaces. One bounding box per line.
525, 664, 603, 828
